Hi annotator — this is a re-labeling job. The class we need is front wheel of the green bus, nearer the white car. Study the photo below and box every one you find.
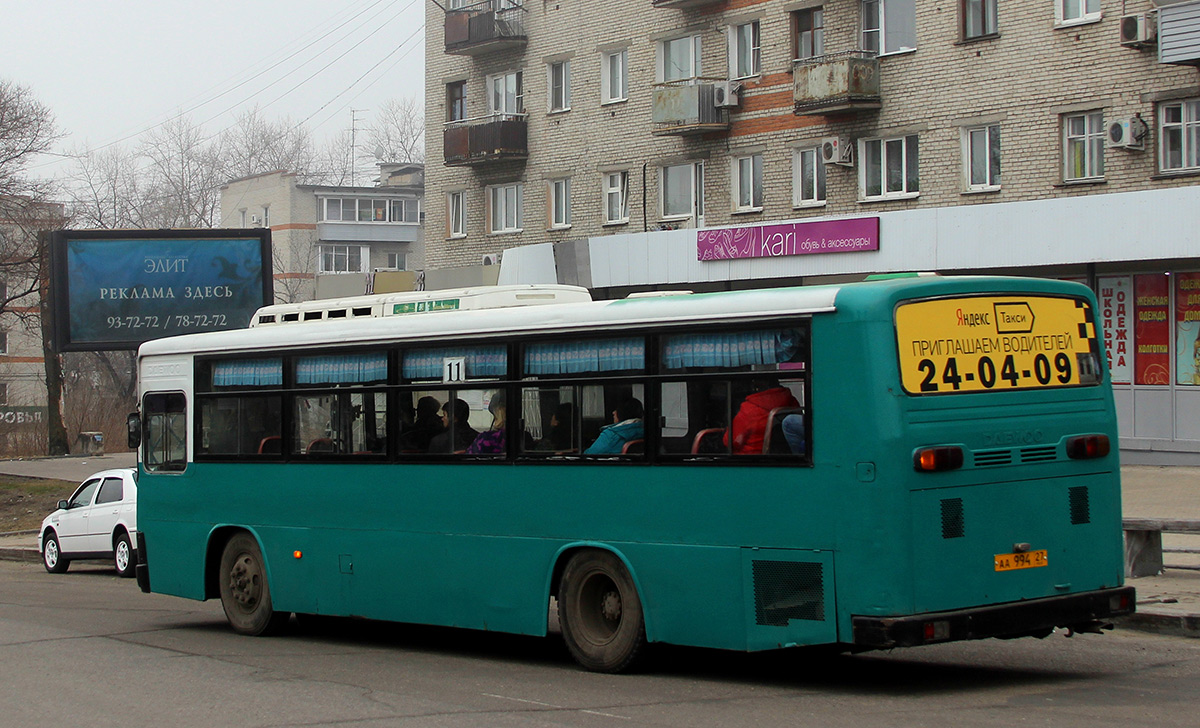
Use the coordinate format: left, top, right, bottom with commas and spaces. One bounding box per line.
218, 533, 290, 636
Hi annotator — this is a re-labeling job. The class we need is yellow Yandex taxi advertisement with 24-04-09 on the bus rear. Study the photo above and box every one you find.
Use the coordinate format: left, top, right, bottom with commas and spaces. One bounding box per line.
895, 295, 1100, 395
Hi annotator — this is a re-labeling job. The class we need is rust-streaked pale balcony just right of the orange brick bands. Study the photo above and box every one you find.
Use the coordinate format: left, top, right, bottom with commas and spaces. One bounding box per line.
792, 50, 883, 116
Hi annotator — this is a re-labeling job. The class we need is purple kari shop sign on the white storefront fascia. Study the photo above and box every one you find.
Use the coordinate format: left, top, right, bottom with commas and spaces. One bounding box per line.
696, 217, 880, 260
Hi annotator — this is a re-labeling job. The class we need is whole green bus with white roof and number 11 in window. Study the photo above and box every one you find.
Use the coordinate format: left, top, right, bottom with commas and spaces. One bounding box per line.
130, 276, 1134, 672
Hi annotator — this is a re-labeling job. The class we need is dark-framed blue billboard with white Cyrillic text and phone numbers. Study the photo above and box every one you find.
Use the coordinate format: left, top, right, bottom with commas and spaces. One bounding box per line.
50, 228, 274, 351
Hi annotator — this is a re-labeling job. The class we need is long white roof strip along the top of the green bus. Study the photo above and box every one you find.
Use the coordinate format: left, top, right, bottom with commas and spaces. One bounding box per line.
139, 285, 840, 356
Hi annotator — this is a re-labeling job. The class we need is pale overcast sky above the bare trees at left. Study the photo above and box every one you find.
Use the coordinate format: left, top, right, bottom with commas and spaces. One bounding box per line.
0, 0, 425, 176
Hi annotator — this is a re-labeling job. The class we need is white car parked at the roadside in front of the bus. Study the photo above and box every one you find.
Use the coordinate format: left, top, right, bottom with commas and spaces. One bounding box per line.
37, 468, 138, 577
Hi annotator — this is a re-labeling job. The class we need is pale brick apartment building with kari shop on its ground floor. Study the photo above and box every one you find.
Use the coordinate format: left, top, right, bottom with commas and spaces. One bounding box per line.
426, 0, 1200, 458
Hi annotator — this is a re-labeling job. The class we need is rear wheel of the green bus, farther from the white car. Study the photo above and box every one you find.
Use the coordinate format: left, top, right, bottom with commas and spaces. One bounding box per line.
558, 550, 646, 673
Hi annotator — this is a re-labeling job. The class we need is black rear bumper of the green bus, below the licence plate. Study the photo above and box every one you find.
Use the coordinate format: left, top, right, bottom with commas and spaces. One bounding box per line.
852, 586, 1134, 649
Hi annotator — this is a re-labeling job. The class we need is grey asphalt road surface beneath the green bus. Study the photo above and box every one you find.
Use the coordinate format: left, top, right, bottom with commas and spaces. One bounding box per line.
0, 562, 1200, 728
